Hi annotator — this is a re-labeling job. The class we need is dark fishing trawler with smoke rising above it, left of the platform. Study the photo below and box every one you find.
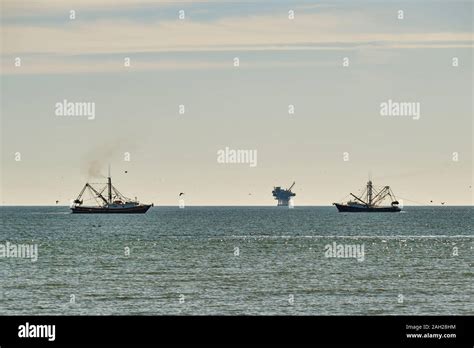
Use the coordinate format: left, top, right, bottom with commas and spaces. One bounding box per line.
71, 171, 153, 214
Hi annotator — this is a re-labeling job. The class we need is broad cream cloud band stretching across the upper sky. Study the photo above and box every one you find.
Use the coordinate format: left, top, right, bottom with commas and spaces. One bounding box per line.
3, 14, 472, 55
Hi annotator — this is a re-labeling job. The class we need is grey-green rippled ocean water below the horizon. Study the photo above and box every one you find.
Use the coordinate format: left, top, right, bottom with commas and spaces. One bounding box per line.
0, 207, 474, 315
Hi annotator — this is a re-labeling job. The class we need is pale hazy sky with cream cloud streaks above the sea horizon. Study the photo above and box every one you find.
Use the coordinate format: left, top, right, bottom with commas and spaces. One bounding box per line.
0, 0, 473, 206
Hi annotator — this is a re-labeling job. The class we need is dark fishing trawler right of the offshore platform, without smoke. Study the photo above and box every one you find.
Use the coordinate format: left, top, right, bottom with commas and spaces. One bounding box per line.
333, 180, 401, 213
